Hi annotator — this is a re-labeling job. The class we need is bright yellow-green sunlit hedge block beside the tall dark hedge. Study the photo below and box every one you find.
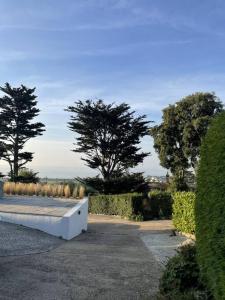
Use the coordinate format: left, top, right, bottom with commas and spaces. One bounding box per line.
173, 192, 196, 234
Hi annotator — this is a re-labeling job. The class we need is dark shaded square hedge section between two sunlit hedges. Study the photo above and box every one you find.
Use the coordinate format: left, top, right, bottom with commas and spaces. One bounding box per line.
149, 191, 172, 219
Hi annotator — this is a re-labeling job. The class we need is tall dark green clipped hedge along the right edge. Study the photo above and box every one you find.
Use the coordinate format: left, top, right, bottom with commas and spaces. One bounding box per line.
195, 112, 225, 300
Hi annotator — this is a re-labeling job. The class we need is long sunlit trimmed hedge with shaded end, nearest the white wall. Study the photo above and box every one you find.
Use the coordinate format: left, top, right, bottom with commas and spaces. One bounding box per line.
89, 193, 145, 220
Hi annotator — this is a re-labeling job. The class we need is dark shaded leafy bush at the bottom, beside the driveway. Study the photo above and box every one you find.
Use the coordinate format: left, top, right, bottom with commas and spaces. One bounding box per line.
158, 244, 212, 300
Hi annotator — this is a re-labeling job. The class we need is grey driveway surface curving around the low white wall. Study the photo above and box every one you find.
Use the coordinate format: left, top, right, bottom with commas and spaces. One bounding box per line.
0, 216, 185, 300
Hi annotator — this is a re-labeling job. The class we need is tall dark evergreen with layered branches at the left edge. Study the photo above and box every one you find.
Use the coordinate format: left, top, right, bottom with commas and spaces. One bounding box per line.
0, 83, 45, 180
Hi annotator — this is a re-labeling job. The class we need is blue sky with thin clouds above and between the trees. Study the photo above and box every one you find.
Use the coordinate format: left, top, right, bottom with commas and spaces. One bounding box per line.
0, 0, 225, 177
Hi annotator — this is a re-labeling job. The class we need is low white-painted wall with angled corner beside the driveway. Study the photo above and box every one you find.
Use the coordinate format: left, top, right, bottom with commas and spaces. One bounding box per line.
0, 198, 88, 240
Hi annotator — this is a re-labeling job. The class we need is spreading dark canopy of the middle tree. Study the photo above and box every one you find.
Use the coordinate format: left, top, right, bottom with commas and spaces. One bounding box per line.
66, 100, 149, 179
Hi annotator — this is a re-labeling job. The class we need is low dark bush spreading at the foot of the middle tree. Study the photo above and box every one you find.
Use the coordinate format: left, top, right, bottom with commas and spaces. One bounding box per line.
82, 173, 148, 195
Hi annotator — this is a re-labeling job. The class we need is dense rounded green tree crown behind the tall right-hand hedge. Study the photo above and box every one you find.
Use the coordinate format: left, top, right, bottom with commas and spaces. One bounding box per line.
150, 93, 222, 176
